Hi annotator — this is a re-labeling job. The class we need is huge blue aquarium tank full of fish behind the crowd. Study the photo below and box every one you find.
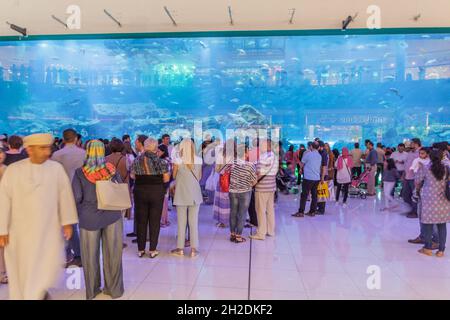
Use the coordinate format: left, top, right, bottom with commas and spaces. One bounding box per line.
0, 34, 450, 145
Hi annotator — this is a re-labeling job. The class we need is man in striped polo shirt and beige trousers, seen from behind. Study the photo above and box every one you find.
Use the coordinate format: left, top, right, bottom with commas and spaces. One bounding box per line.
250, 140, 278, 240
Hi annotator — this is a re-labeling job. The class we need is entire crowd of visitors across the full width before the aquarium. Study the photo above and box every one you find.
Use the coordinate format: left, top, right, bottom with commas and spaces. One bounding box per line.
0, 129, 450, 299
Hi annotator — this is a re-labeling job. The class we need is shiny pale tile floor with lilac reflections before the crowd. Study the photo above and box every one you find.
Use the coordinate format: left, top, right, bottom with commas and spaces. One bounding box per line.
0, 190, 450, 300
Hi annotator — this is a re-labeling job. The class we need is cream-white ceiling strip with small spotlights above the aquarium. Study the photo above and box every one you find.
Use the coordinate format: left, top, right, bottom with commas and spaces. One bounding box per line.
0, 0, 450, 36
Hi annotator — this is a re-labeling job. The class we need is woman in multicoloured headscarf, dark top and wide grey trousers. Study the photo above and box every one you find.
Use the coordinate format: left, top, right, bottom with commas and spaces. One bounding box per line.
72, 140, 124, 300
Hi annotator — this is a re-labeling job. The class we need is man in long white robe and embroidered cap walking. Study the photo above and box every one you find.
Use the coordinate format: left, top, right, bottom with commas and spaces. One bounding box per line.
0, 134, 78, 300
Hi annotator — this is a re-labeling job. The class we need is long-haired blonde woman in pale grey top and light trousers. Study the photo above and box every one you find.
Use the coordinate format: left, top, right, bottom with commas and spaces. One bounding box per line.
171, 139, 203, 257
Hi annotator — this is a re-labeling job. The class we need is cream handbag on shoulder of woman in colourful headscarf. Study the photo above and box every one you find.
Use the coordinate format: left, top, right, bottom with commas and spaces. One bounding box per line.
95, 180, 131, 211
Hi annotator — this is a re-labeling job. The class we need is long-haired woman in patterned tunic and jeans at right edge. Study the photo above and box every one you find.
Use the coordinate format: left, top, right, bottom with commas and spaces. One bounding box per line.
415, 149, 450, 257
